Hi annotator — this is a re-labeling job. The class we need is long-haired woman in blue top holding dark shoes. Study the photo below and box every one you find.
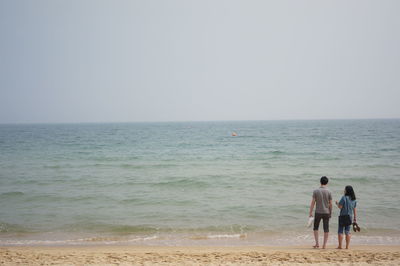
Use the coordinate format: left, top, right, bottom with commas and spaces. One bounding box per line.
336, 186, 357, 249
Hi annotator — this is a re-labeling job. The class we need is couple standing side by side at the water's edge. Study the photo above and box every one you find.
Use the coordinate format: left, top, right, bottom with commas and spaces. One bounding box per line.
310, 176, 357, 249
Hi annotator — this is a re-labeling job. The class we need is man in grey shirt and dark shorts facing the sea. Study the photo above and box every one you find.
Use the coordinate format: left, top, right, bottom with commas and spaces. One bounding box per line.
310, 176, 332, 248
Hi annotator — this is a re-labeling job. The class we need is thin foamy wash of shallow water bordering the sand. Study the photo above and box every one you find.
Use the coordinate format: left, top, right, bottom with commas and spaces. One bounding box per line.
0, 232, 400, 246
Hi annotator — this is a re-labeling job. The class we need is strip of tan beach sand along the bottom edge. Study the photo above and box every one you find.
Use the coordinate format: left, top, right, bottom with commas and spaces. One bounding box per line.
0, 246, 400, 265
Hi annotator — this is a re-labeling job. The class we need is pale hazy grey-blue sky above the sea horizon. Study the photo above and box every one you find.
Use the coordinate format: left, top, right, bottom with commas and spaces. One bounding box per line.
0, 0, 400, 123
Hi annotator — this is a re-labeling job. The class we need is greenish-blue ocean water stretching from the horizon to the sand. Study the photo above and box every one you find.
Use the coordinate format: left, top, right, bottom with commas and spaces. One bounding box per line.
0, 120, 400, 245
